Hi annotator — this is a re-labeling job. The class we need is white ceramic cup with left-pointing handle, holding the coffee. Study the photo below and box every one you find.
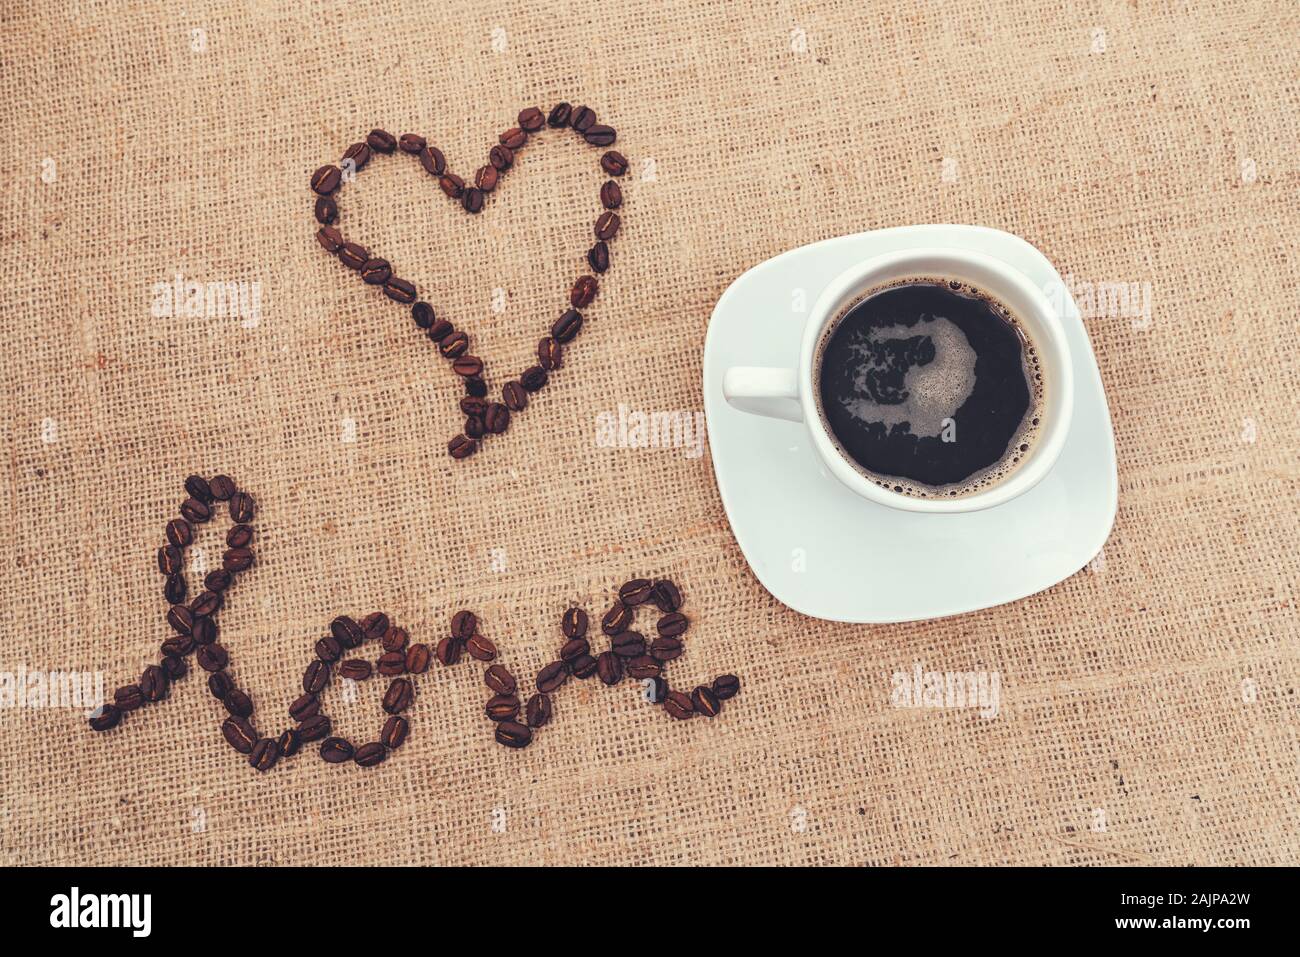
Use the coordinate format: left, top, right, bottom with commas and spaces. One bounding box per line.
723, 248, 1074, 514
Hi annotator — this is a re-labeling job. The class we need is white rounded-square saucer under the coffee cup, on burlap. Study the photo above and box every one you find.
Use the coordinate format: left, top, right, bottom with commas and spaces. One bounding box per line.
703, 225, 1118, 623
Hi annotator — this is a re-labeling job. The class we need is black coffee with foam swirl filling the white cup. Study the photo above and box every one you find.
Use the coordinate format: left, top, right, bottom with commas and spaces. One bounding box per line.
818, 278, 1043, 498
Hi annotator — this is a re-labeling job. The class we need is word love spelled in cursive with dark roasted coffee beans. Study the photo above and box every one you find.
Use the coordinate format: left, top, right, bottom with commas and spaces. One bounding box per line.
90, 475, 740, 771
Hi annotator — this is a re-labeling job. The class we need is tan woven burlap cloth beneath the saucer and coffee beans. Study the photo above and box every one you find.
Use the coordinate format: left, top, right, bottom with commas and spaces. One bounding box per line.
0, 0, 1300, 865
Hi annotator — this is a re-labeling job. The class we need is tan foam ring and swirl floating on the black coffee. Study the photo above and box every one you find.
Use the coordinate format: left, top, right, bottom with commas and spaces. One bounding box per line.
813, 276, 1045, 498
